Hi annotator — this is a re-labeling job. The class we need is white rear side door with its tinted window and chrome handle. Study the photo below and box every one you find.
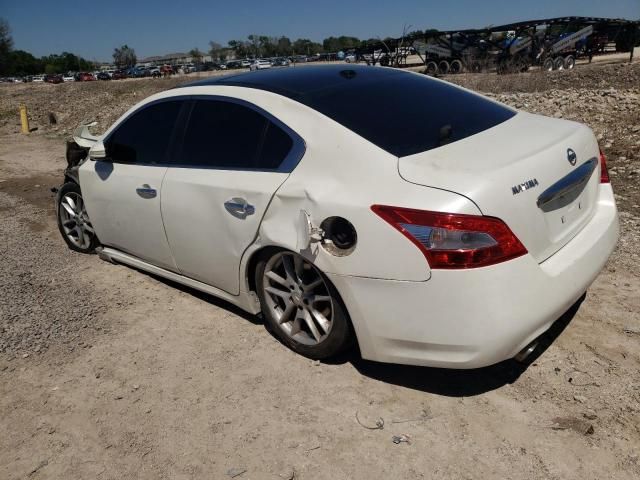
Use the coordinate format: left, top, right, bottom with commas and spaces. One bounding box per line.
162, 97, 304, 295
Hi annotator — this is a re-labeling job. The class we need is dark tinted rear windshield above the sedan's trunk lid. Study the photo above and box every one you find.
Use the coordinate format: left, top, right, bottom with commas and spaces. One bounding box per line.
295, 72, 515, 157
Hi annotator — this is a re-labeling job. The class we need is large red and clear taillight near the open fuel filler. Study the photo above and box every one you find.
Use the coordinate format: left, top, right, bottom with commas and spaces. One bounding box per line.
371, 205, 527, 269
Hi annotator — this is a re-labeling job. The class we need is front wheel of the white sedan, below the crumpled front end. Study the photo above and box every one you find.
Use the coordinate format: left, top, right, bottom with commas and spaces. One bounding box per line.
56, 182, 100, 253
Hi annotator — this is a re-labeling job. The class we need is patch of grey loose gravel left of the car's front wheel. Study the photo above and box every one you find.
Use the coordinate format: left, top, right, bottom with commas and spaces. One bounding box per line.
0, 193, 107, 358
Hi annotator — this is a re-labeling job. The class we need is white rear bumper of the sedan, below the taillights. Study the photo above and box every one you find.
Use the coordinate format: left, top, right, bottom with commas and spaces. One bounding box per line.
329, 185, 618, 368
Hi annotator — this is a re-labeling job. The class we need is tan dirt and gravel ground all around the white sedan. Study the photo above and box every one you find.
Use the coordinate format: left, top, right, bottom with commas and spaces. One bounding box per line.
0, 58, 640, 480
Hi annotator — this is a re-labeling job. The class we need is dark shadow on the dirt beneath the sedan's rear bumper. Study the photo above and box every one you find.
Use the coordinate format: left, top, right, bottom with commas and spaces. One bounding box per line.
327, 295, 585, 397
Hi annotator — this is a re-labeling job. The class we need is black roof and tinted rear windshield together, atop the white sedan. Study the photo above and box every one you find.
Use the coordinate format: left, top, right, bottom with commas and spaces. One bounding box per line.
176, 64, 515, 157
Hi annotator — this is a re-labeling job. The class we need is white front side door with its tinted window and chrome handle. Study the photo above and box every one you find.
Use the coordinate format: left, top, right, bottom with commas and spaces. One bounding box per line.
80, 100, 184, 270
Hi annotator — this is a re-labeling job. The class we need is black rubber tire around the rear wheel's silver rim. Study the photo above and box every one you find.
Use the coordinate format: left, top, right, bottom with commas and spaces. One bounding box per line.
255, 251, 353, 360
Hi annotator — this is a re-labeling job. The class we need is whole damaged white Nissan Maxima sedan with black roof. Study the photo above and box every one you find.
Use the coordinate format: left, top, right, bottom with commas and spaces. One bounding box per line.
57, 64, 618, 368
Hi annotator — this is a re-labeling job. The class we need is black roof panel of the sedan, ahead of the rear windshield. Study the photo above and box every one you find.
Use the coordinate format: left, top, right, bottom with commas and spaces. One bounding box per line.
181, 64, 402, 100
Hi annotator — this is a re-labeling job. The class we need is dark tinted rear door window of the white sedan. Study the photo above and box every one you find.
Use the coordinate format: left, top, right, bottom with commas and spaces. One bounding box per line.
177, 100, 293, 170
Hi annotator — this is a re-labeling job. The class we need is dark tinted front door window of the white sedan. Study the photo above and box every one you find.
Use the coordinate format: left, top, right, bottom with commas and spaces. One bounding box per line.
106, 100, 183, 164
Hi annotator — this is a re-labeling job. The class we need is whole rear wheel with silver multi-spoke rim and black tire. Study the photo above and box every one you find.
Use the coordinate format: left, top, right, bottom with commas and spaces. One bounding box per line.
255, 250, 353, 360
